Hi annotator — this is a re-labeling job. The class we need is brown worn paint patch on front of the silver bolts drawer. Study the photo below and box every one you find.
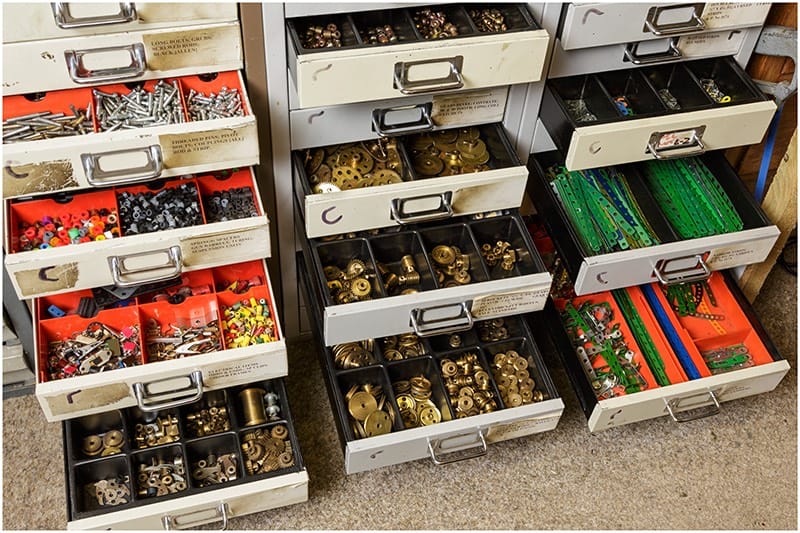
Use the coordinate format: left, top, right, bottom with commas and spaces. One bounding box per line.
3, 160, 78, 198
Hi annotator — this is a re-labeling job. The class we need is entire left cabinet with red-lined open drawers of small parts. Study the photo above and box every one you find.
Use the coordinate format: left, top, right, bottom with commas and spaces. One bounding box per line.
3, 2, 308, 529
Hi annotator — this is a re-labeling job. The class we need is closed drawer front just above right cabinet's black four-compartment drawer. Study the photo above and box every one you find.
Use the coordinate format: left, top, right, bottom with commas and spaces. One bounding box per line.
547, 27, 761, 78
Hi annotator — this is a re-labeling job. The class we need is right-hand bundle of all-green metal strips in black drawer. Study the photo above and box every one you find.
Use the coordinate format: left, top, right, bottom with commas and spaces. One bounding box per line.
643, 157, 743, 239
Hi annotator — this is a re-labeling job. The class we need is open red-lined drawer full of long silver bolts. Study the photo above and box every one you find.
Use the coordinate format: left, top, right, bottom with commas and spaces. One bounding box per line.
3, 71, 259, 198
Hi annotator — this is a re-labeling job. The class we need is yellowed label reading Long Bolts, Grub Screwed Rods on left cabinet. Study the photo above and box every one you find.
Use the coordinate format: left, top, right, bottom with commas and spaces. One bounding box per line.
142, 25, 241, 70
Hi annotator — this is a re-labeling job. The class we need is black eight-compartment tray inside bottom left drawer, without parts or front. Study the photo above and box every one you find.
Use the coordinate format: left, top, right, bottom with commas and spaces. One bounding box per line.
63, 379, 305, 522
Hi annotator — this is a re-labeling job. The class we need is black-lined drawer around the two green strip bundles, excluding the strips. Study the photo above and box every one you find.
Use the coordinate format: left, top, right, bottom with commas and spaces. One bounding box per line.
529, 152, 780, 295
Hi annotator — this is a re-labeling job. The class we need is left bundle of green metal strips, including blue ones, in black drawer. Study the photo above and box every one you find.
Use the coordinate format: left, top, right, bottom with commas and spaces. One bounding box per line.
547, 165, 660, 254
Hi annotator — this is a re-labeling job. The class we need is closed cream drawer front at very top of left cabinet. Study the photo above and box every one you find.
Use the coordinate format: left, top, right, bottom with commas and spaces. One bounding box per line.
3, 2, 238, 43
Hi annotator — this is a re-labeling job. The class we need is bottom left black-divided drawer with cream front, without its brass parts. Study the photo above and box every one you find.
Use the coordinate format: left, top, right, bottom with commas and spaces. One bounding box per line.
63, 379, 308, 531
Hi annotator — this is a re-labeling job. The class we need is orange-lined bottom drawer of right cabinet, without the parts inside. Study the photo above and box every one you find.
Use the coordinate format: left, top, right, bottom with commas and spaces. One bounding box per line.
547, 272, 789, 431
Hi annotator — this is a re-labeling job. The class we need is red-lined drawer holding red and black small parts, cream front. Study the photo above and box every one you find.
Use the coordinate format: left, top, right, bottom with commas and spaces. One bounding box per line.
5, 168, 271, 298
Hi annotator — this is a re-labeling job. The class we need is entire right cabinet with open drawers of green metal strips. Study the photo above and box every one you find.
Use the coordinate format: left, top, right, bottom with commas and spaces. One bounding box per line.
523, 3, 789, 431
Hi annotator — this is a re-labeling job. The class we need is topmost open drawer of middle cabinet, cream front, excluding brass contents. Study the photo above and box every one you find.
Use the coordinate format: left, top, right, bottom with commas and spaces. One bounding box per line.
287, 4, 548, 108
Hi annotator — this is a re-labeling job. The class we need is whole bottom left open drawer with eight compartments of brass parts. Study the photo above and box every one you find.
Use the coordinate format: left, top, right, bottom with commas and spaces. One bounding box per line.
63, 378, 308, 530
